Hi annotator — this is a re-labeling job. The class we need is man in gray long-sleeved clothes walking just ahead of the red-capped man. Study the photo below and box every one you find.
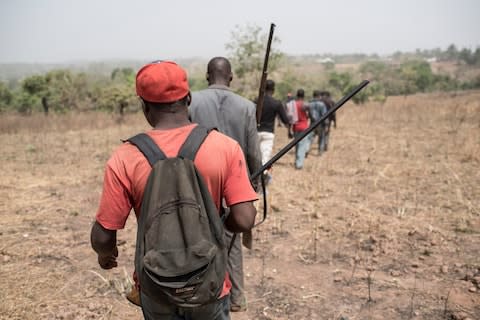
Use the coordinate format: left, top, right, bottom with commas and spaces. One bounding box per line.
189, 57, 262, 311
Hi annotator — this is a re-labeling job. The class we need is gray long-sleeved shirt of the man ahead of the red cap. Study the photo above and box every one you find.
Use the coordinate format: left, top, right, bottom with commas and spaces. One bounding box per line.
189, 85, 262, 178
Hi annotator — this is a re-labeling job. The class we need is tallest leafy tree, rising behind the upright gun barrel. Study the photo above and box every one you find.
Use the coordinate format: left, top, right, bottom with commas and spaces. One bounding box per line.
225, 25, 283, 97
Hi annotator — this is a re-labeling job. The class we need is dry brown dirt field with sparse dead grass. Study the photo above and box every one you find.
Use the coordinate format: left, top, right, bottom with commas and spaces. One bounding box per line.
0, 92, 480, 320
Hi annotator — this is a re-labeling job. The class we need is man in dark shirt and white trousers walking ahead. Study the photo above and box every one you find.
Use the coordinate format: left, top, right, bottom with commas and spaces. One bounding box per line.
257, 80, 289, 164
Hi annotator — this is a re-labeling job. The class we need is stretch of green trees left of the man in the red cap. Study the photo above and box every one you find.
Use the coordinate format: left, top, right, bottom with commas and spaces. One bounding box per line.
0, 68, 136, 114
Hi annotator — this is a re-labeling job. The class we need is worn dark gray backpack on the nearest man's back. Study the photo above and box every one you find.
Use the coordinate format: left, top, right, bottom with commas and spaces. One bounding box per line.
127, 126, 227, 307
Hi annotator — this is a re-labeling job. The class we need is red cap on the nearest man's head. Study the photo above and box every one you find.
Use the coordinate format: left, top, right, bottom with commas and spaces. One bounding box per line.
136, 61, 190, 103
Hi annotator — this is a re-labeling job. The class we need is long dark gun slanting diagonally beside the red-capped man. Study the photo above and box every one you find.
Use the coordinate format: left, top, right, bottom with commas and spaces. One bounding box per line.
250, 80, 370, 226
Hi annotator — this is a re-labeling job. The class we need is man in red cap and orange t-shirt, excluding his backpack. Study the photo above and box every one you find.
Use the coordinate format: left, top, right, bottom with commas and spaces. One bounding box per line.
91, 61, 257, 320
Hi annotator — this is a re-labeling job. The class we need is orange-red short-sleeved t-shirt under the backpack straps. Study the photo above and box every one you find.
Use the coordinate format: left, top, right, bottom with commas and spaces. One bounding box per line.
96, 124, 257, 297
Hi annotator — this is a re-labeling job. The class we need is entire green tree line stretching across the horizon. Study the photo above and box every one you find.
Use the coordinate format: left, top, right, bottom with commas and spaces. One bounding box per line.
0, 25, 480, 114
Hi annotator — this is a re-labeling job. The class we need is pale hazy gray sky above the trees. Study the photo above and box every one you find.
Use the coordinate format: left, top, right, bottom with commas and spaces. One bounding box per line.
0, 0, 480, 63
